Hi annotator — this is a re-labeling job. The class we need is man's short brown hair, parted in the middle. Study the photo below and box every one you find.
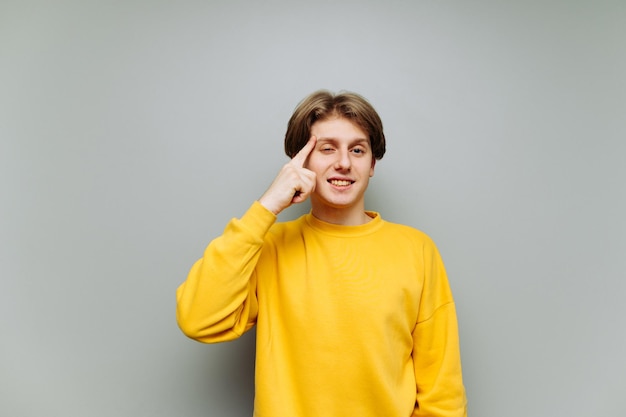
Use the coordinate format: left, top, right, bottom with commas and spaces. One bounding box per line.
285, 90, 385, 159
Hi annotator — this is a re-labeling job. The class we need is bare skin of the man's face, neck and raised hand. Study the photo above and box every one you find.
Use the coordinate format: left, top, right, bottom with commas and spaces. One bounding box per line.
259, 118, 376, 225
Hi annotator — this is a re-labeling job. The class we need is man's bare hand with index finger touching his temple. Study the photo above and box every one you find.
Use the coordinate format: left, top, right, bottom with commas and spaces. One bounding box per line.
259, 136, 317, 215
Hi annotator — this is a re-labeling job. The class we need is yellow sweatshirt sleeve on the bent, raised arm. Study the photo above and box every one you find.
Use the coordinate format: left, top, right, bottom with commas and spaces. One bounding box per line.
176, 201, 276, 343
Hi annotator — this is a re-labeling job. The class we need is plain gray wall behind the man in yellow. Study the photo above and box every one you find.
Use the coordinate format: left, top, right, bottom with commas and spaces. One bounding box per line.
0, 0, 626, 417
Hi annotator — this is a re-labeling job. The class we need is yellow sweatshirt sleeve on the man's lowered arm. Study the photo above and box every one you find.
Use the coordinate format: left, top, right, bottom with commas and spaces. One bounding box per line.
413, 239, 467, 417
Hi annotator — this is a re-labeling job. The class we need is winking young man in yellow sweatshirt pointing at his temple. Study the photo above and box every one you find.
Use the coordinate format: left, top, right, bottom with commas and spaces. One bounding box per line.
177, 91, 466, 417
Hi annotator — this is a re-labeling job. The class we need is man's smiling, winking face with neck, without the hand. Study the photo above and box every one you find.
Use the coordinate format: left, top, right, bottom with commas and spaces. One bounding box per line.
305, 118, 376, 212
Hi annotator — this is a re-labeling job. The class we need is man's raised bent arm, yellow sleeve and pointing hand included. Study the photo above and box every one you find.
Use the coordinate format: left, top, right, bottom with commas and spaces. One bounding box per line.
176, 137, 316, 343
